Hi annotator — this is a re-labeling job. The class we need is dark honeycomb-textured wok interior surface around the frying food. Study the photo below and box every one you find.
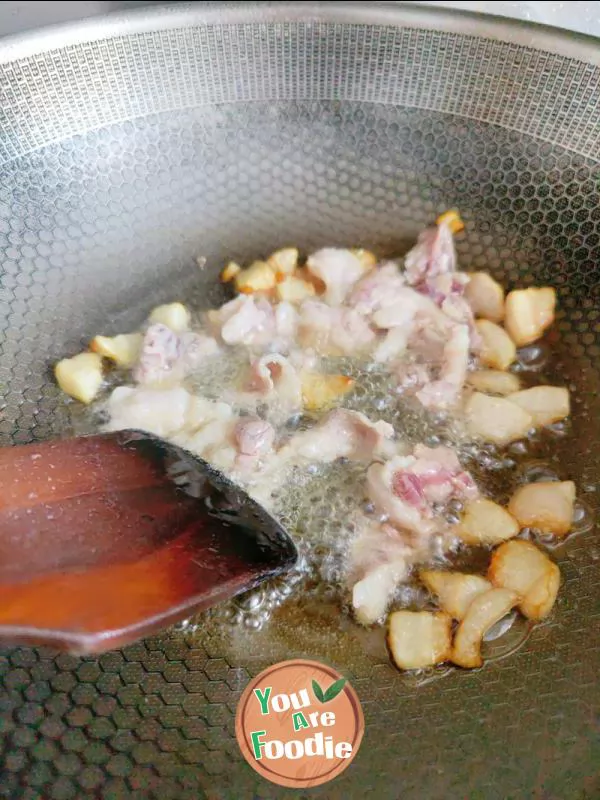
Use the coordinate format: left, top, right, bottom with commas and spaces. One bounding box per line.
0, 11, 600, 799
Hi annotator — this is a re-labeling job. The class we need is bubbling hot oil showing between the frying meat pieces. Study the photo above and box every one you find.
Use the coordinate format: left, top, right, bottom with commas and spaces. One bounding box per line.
63, 320, 593, 684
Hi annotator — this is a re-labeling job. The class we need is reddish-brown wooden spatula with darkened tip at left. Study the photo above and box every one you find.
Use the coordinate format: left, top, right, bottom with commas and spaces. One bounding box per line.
0, 431, 296, 653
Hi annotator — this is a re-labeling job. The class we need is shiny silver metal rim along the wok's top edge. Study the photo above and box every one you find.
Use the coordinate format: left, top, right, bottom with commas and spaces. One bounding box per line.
0, 0, 600, 66
